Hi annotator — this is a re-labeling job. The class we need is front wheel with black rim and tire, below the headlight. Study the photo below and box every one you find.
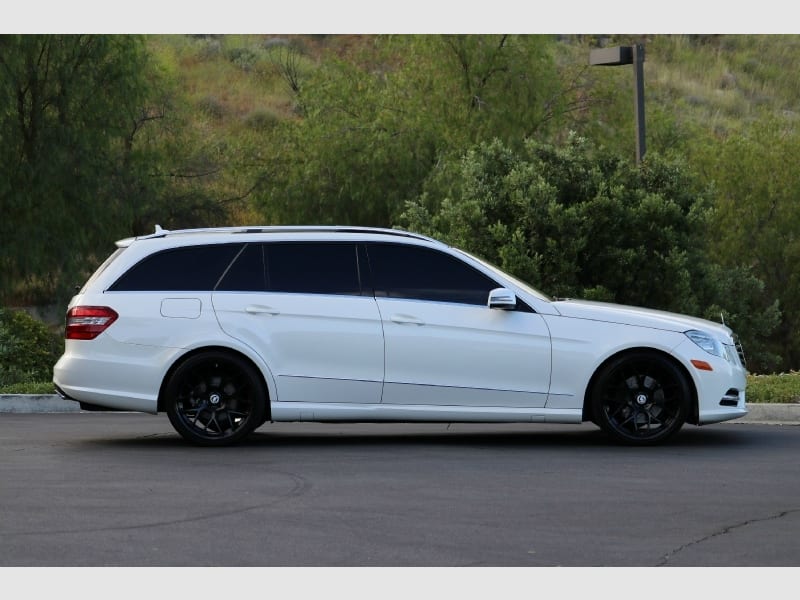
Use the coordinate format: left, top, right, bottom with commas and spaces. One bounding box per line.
591, 352, 692, 446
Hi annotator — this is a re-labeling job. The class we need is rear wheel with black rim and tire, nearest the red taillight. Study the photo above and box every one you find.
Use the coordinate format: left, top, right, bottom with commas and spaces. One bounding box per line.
164, 351, 267, 446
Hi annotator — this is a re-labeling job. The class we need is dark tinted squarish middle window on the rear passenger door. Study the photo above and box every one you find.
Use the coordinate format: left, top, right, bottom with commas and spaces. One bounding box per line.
264, 242, 361, 296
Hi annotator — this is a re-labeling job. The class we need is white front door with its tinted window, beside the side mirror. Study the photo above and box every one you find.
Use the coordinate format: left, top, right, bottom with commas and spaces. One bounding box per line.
368, 244, 551, 408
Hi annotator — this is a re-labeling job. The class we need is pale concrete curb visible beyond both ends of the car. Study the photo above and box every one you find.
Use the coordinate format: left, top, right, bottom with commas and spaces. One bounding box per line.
0, 394, 800, 425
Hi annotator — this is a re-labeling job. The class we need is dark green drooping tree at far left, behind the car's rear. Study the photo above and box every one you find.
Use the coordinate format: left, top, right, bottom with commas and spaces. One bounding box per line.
0, 35, 247, 304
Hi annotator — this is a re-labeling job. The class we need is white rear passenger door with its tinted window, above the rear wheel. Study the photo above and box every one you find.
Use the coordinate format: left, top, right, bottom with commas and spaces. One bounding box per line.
212, 242, 383, 403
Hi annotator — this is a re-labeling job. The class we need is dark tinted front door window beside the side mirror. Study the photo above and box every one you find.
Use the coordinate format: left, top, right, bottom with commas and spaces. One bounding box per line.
368, 244, 499, 304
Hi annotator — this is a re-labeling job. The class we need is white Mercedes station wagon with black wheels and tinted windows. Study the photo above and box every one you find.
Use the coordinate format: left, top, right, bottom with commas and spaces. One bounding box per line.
54, 227, 747, 445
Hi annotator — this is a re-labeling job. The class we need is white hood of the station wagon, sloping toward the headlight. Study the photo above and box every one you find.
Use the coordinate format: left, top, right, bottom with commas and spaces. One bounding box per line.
553, 299, 732, 340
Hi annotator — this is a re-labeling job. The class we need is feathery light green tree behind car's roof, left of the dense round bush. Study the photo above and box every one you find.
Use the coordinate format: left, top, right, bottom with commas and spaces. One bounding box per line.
256, 35, 558, 226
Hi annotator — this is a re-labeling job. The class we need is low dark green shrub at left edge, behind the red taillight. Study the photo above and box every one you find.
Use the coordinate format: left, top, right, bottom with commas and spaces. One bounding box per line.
0, 309, 64, 386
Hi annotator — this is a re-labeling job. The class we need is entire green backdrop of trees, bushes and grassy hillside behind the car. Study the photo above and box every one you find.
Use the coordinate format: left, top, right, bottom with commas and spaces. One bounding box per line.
0, 35, 800, 370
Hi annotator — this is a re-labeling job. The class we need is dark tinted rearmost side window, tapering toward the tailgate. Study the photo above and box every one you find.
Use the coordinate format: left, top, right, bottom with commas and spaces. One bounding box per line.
109, 244, 242, 292
